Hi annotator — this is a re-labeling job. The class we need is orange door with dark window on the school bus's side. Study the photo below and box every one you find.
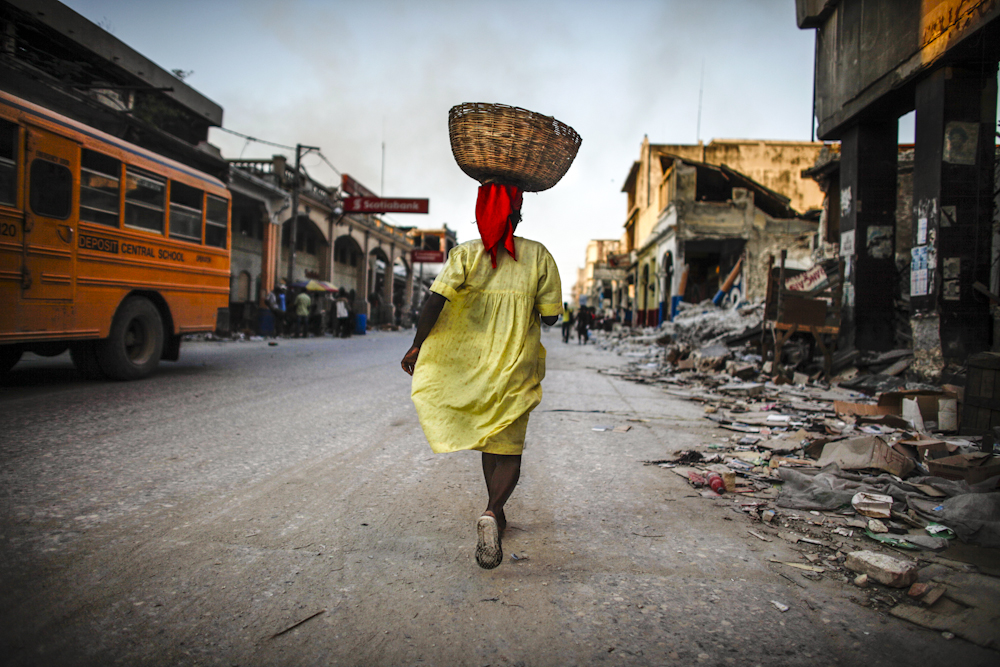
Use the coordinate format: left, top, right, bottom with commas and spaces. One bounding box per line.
21, 125, 80, 300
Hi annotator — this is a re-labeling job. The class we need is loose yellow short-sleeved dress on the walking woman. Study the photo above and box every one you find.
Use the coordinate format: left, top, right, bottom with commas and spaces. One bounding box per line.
411, 237, 562, 454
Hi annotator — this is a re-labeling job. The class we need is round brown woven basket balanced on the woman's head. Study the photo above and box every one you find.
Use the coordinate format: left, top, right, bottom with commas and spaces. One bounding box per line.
448, 102, 581, 192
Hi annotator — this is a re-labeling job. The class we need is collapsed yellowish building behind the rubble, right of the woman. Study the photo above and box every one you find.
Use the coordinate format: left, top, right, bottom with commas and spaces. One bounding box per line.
612, 139, 823, 326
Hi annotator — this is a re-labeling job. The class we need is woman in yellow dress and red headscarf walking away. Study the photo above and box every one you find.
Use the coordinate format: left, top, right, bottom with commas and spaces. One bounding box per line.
402, 183, 562, 569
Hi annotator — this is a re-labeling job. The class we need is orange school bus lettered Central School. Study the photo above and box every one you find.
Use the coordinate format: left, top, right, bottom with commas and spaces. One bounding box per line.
0, 92, 230, 380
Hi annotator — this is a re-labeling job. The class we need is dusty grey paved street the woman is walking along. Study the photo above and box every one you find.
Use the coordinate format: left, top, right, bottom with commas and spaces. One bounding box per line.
0, 330, 996, 667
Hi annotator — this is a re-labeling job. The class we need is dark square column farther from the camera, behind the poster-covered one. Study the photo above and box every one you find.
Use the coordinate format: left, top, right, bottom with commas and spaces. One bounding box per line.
840, 119, 899, 351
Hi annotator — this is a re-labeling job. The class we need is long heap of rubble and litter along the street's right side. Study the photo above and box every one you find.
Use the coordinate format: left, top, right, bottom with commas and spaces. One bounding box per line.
598, 309, 1000, 649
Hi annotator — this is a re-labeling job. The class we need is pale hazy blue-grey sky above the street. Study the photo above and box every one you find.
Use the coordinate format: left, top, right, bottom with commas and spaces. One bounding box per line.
64, 0, 824, 298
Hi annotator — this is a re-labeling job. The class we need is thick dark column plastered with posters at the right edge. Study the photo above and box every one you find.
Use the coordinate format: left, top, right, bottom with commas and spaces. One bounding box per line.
910, 68, 997, 380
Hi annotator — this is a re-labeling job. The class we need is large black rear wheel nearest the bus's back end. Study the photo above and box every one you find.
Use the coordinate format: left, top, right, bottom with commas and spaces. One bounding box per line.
97, 297, 163, 380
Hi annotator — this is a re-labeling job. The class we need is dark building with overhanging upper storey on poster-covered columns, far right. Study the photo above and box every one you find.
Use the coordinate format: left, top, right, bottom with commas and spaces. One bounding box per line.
796, 0, 1000, 381
